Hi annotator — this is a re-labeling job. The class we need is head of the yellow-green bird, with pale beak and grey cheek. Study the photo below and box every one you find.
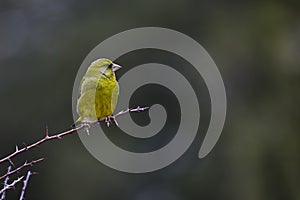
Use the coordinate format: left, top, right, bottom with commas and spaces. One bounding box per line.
90, 58, 121, 78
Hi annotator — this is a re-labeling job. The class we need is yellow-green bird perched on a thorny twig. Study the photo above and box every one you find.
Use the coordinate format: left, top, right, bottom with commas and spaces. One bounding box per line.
75, 58, 122, 126
